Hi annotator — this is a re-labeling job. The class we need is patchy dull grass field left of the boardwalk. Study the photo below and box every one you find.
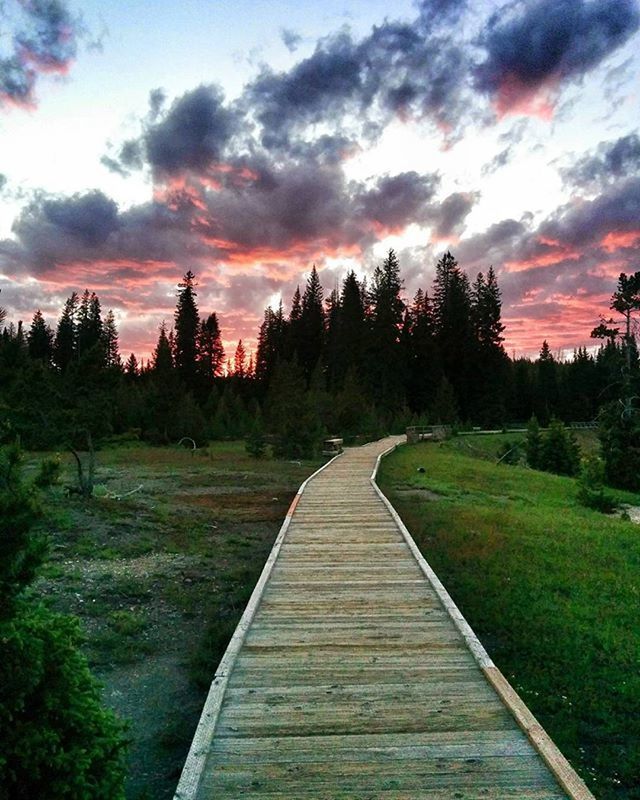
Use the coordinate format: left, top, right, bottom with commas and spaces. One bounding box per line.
28, 443, 319, 800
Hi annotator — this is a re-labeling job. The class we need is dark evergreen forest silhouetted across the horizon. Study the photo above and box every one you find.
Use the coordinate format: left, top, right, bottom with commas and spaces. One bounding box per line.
0, 250, 638, 457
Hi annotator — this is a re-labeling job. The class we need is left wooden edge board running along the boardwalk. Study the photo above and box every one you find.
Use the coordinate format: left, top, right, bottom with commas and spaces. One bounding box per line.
173, 453, 342, 800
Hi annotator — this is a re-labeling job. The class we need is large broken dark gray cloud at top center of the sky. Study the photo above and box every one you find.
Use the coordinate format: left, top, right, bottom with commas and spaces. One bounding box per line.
242, 21, 469, 149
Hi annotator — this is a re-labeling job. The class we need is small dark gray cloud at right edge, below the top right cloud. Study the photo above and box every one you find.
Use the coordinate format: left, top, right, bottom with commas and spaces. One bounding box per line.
561, 133, 640, 191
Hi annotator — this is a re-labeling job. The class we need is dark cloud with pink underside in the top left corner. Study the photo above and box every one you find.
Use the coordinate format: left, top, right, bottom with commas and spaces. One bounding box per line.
0, 0, 85, 108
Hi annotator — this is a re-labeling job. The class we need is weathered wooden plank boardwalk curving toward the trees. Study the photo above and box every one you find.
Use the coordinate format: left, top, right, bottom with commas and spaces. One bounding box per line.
175, 437, 592, 800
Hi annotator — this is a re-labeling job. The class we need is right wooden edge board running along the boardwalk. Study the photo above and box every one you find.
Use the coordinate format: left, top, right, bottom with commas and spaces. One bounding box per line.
371, 444, 595, 800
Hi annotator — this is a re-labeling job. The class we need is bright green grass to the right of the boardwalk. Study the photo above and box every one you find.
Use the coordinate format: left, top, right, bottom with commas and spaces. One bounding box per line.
380, 434, 640, 800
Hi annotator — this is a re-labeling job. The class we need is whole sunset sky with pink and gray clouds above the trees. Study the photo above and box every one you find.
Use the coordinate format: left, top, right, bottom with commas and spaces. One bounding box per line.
0, 0, 640, 356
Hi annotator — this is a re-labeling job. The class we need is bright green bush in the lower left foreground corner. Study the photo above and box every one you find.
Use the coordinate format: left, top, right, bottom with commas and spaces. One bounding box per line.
0, 447, 125, 800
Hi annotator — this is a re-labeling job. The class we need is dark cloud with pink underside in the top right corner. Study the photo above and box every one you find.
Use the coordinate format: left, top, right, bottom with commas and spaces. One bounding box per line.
476, 0, 640, 105
